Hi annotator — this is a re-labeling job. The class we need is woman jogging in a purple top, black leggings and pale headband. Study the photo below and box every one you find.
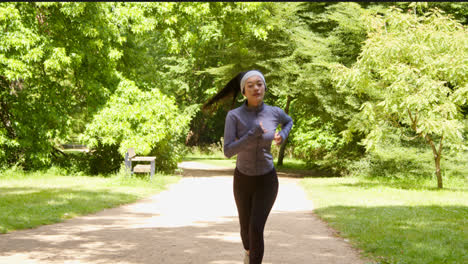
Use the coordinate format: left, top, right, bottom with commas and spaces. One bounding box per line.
224, 70, 293, 264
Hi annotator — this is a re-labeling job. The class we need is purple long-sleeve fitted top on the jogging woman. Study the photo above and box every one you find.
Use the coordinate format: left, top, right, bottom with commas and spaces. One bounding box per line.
224, 101, 293, 176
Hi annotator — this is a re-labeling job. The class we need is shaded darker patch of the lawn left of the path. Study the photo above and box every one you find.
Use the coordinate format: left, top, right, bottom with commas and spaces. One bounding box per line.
0, 185, 145, 234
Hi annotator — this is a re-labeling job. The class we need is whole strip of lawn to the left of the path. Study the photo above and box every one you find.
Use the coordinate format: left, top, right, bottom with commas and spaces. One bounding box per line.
0, 168, 180, 233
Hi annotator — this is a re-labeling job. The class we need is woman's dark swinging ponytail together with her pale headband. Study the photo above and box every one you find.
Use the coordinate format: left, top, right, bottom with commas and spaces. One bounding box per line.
202, 70, 268, 111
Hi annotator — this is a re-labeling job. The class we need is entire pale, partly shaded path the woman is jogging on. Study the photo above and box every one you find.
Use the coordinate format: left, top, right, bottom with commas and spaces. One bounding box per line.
0, 162, 365, 264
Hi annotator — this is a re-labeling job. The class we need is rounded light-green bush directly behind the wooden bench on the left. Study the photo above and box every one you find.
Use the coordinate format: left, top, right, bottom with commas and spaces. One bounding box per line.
81, 79, 193, 172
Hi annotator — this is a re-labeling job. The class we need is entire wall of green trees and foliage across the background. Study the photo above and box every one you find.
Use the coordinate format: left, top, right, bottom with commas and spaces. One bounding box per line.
0, 2, 468, 186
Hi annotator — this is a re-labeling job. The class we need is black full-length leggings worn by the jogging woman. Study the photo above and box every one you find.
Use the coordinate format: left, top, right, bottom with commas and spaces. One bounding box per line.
233, 168, 278, 264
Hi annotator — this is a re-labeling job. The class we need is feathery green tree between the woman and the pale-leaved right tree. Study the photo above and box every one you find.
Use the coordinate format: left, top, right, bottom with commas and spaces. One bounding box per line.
260, 2, 366, 172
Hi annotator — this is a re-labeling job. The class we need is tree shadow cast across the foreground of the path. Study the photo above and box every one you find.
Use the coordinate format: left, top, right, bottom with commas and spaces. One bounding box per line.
0, 212, 366, 264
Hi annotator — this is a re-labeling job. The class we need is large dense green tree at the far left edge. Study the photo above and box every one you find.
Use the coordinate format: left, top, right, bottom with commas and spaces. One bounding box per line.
0, 2, 159, 168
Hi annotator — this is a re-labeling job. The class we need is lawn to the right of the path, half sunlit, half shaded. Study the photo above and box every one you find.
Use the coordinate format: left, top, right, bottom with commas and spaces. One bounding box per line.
301, 175, 468, 264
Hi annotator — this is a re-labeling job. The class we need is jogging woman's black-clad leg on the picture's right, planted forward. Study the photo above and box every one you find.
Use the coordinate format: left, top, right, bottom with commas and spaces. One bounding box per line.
249, 169, 278, 264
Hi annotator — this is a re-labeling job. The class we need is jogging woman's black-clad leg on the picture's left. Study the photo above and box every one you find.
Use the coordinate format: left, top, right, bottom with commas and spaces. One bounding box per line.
233, 168, 253, 253
